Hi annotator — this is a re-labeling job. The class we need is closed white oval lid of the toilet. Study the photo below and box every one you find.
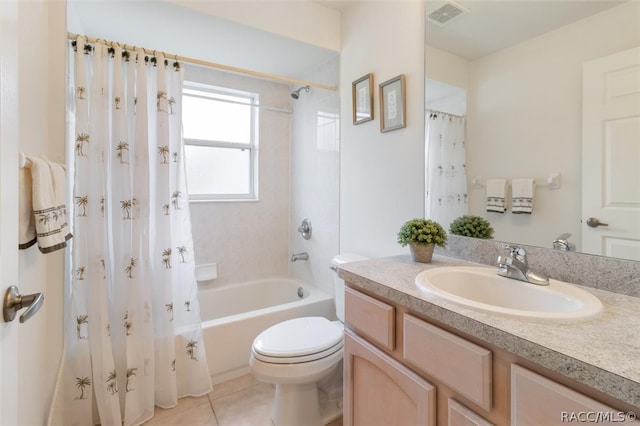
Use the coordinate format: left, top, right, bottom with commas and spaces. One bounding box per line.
253, 317, 343, 358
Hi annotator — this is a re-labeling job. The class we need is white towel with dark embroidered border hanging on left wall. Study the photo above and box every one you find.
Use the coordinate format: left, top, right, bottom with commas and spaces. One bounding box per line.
20, 158, 72, 253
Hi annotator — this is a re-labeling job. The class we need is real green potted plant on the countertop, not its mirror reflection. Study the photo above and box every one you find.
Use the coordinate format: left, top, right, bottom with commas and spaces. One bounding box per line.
398, 218, 447, 263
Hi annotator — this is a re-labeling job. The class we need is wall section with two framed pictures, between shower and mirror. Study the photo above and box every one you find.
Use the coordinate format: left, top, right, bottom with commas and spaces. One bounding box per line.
340, 1, 424, 257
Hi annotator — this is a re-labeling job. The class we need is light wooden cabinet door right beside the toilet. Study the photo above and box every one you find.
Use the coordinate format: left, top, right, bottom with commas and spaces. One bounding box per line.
343, 330, 436, 426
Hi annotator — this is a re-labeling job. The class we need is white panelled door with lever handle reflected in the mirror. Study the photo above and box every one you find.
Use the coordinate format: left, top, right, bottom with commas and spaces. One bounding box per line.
582, 47, 640, 260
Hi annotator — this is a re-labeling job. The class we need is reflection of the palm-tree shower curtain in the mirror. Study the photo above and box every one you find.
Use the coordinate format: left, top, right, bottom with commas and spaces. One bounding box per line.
425, 110, 469, 230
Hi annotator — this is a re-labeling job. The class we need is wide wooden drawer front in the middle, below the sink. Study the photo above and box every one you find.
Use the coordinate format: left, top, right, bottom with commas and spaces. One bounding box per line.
402, 314, 492, 411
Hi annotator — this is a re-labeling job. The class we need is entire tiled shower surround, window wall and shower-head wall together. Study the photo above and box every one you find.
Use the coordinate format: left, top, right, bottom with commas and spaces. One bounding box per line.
185, 55, 340, 294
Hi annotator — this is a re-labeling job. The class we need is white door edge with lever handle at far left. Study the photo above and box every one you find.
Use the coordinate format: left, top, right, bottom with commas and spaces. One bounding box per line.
0, 1, 19, 425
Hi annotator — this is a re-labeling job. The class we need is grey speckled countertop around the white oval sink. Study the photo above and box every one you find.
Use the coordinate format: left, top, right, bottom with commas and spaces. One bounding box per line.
339, 255, 640, 409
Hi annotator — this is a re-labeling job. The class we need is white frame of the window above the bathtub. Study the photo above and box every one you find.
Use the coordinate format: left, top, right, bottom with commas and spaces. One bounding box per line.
182, 80, 259, 202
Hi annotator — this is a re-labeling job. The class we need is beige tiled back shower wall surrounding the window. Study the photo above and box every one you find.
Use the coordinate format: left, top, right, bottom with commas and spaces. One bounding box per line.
185, 67, 292, 286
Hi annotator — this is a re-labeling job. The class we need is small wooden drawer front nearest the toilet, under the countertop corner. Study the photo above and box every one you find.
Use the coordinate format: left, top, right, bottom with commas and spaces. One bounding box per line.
344, 287, 395, 351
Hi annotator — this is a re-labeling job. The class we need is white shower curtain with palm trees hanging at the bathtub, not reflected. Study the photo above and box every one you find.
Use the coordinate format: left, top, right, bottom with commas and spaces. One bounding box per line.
49, 37, 211, 426
